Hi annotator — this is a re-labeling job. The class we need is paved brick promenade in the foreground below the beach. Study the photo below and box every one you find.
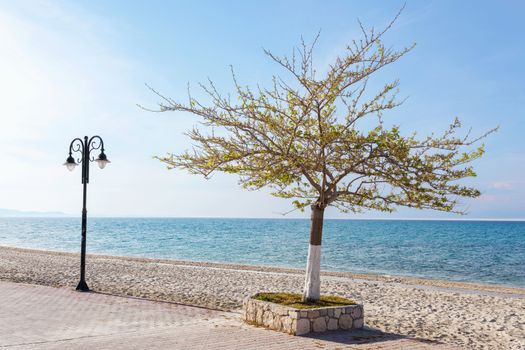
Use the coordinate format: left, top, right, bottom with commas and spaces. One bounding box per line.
0, 281, 457, 350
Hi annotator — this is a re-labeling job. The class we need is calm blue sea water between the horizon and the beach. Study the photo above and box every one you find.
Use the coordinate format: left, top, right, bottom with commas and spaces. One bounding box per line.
0, 218, 525, 287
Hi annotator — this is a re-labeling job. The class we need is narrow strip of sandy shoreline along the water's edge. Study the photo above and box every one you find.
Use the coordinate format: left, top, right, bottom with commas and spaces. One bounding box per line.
0, 245, 525, 298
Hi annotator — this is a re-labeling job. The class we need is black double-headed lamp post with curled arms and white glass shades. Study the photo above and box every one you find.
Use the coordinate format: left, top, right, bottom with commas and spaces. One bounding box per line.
64, 136, 110, 292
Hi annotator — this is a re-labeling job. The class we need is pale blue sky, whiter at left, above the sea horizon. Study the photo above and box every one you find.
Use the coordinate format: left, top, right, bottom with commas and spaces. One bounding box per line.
0, 0, 525, 219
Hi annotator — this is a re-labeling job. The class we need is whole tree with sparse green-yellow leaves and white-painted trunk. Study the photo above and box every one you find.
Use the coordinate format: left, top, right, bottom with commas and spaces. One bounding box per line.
145, 14, 494, 302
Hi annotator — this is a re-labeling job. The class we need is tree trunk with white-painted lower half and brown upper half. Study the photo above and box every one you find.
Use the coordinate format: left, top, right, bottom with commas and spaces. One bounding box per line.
303, 203, 324, 302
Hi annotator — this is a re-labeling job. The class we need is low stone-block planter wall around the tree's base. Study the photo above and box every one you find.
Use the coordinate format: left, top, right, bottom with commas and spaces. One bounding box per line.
241, 298, 364, 335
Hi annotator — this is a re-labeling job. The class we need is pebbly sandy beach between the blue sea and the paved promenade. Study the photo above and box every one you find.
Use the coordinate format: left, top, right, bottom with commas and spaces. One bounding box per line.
0, 247, 525, 349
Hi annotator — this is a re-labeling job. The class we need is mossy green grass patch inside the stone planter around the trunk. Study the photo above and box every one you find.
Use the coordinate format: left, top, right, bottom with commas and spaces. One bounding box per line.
252, 293, 356, 309
